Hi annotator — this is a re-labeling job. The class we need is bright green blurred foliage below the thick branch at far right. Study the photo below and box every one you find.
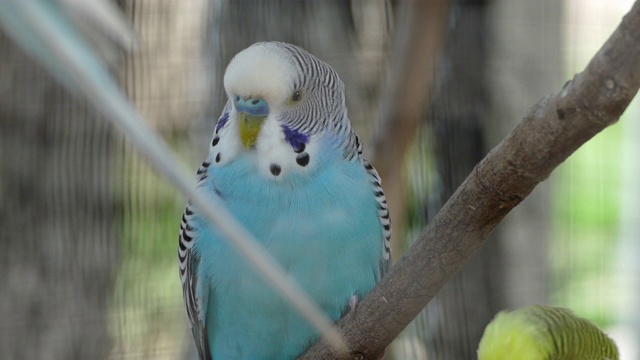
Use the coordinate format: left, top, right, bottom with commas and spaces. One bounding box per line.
549, 119, 631, 326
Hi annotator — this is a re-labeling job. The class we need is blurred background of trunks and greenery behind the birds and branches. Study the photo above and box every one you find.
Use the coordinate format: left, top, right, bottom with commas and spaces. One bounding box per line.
0, 0, 640, 360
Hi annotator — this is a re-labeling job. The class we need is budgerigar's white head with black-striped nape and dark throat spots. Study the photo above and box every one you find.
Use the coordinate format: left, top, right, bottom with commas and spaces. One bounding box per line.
214, 42, 356, 180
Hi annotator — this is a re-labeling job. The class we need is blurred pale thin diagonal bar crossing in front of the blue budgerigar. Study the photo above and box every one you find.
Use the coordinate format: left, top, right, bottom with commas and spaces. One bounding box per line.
0, 0, 346, 353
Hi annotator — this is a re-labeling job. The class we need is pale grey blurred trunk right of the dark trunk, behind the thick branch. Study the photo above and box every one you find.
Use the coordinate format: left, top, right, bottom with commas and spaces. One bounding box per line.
482, 0, 564, 309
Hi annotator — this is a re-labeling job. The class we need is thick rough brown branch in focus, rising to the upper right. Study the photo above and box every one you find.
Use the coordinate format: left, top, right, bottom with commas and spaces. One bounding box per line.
301, 0, 640, 359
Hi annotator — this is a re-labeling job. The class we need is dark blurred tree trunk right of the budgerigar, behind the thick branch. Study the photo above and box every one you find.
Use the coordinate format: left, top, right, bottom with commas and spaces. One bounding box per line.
420, 0, 504, 359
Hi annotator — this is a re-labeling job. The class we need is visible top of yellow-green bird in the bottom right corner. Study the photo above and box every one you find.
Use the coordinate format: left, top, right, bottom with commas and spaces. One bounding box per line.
478, 305, 619, 360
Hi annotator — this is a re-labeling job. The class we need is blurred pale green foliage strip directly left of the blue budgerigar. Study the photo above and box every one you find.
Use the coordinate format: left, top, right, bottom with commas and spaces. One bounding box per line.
110, 137, 191, 359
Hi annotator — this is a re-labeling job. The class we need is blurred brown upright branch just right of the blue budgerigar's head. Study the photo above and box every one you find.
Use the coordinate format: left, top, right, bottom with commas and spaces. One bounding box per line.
366, 0, 449, 249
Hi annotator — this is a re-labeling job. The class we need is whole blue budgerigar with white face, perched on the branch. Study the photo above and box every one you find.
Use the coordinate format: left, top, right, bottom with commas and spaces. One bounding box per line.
179, 42, 391, 359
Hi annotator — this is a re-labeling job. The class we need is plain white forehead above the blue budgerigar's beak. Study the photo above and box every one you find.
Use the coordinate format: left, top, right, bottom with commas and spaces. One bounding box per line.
224, 43, 295, 106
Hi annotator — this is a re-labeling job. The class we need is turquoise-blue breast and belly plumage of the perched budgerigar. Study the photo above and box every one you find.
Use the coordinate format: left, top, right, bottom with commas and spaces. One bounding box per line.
194, 134, 383, 359
